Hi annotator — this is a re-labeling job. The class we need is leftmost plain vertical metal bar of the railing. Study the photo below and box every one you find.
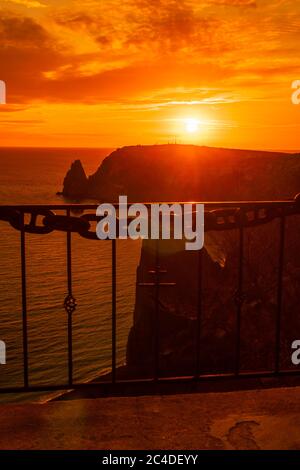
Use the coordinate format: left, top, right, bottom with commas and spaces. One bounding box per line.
21, 213, 29, 388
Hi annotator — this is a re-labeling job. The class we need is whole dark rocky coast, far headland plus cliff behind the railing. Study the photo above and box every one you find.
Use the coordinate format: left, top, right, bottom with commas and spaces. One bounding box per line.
63, 145, 300, 377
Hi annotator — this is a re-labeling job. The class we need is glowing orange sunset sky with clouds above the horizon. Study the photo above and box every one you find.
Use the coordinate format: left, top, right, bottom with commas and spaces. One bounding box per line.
0, 0, 300, 149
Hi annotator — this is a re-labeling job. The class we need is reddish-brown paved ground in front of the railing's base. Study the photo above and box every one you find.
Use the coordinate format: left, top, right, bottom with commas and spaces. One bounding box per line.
0, 387, 300, 450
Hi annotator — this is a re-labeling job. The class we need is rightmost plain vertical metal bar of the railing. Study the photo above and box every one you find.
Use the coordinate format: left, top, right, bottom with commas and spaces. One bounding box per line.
275, 216, 285, 374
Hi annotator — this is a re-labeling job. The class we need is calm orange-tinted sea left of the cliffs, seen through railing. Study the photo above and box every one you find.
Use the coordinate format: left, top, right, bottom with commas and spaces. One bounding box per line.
0, 149, 140, 401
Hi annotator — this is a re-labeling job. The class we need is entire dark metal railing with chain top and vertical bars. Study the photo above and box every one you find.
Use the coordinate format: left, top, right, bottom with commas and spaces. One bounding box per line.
0, 195, 300, 393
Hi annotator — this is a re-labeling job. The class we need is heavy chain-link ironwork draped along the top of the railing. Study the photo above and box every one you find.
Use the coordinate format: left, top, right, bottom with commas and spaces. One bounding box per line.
0, 194, 300, 240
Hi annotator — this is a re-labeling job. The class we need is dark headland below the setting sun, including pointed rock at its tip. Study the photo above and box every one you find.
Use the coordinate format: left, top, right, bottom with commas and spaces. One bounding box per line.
63, 144, 300, 202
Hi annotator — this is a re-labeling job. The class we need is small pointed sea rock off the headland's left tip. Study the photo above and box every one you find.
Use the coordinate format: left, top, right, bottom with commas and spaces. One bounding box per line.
63, 160, 88, 199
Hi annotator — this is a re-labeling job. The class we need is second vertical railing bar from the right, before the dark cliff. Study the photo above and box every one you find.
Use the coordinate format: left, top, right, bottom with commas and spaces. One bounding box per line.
235, 227, 244, 375
